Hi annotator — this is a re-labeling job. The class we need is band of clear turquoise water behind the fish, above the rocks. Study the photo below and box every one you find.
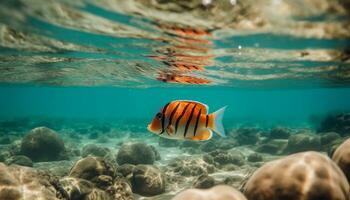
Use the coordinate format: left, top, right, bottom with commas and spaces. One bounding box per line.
0, 86, 350, 127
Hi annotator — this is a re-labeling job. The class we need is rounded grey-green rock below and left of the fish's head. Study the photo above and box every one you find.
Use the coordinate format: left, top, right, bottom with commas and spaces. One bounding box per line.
117, 142, 156, 165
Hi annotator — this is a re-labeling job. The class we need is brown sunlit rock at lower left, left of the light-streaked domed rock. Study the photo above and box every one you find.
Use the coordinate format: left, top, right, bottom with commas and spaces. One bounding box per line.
69, 156, 115, 182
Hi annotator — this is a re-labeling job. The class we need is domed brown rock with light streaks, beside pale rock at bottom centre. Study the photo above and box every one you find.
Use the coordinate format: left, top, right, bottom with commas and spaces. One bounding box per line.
132, 165, 165, 196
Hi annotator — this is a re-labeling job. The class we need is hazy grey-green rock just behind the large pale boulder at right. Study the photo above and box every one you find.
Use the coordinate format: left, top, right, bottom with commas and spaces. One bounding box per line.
285, 133, 321, 153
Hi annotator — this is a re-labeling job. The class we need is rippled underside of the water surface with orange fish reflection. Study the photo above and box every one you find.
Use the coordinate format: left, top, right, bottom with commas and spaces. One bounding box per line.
0, 0, 350, 88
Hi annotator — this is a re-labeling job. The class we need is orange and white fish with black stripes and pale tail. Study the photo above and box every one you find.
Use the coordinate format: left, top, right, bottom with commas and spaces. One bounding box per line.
148, 100, 226, 140
